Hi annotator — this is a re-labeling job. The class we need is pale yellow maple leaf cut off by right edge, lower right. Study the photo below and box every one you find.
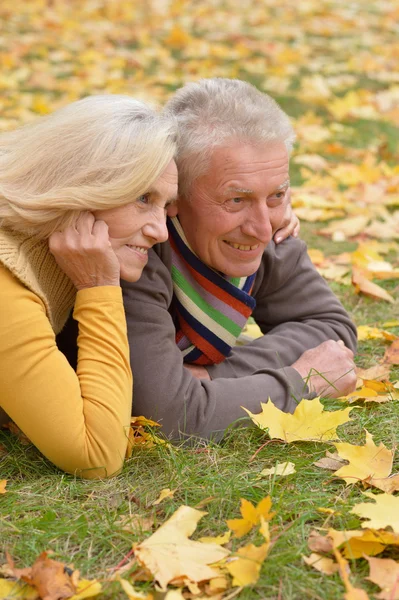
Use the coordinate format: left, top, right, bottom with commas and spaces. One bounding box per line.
350, 492, 399, 533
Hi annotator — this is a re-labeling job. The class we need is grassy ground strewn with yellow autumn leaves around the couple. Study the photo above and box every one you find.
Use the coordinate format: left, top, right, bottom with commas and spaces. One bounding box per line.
0, 0, 399, 600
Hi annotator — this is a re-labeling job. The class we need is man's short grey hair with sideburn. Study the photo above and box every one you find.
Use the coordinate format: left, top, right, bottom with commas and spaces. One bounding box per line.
165, 77, 295, 197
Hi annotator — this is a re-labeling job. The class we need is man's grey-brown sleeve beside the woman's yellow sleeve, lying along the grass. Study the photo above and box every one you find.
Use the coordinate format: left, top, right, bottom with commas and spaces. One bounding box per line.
122, 245, 306, 438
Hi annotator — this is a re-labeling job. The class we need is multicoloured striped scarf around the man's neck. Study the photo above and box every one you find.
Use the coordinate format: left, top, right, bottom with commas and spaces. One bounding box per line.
168, 217, 256, 365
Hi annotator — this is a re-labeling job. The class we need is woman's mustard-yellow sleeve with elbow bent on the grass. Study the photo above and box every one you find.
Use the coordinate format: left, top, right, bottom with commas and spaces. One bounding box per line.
0, 266, 132, 478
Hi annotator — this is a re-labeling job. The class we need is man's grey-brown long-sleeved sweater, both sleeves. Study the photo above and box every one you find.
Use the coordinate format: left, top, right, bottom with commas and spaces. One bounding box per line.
122, 238, 356, 438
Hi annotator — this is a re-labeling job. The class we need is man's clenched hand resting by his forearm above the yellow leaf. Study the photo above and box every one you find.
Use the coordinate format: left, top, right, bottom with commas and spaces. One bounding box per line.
292, 340, 356, 398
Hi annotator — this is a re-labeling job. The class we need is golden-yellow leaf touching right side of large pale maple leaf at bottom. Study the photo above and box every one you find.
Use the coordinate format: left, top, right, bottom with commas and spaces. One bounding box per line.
226, 542, 270, 586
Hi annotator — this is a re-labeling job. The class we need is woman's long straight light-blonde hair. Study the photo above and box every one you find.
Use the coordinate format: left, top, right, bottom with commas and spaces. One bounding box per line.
0, 95, 176, 238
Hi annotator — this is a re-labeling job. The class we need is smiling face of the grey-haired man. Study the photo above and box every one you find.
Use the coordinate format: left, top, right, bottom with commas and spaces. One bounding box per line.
178, 142, 289, 277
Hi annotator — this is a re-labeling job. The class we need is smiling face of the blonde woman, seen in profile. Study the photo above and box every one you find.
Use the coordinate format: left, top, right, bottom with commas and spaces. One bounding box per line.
94, 160, 177, 281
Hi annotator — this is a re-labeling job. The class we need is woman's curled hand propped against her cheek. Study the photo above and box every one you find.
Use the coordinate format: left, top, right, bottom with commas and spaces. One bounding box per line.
49, 212, 120, 290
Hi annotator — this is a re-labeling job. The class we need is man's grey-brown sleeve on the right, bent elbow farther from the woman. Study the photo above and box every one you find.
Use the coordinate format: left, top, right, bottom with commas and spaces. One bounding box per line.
207, 238, 356, 379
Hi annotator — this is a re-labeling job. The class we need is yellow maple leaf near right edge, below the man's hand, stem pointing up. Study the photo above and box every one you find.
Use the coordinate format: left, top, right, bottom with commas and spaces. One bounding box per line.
334, 431, 393, 487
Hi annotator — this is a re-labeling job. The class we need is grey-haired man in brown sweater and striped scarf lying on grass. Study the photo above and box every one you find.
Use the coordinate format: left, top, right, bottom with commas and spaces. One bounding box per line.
123, 79, 356, 438
